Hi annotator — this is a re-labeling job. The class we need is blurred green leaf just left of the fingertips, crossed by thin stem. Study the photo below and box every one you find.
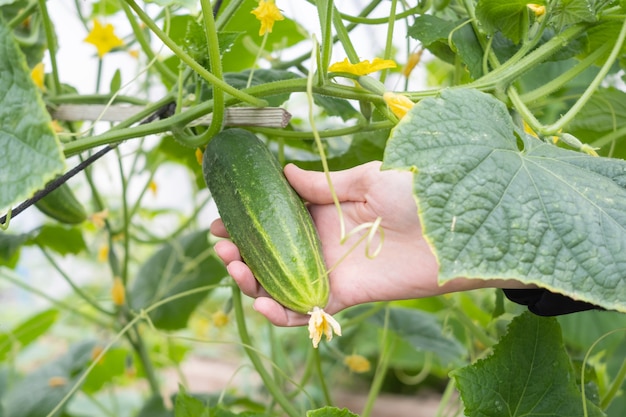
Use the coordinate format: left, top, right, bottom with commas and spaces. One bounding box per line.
129, 230, 227, 329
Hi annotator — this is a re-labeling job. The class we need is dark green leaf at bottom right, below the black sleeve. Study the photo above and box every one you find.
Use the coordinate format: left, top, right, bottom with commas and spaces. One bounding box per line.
452, 312, 604, 417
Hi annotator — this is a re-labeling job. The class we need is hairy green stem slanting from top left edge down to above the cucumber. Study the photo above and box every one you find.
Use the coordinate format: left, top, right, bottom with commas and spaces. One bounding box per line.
125, 0, 267, 107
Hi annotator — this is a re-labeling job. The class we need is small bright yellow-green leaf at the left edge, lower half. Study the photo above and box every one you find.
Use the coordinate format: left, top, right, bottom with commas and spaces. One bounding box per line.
0, 309, 59, 362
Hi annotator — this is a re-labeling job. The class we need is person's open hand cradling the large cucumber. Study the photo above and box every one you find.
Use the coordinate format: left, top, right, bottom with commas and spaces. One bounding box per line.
211, 162, 516, 326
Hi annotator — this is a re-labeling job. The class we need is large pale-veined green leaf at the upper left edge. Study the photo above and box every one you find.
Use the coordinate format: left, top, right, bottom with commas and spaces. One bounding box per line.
0, 17, 65, 211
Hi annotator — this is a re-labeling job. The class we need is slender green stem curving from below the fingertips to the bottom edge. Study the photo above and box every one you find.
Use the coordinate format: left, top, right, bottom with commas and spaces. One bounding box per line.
232, 284, 302, 417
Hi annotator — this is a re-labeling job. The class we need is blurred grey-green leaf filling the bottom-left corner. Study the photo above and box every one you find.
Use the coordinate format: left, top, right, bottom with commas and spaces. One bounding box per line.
5, 342, 95, 417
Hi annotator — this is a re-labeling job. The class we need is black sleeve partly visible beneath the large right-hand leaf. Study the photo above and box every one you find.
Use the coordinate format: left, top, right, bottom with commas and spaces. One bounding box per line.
503, 288, 602, 316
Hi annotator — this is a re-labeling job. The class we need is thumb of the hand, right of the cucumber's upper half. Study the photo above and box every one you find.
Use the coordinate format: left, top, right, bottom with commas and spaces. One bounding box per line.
285, 161, 381, 204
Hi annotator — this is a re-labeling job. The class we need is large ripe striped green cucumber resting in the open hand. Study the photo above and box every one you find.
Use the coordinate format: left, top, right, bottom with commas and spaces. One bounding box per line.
202, 129, 329, 314
